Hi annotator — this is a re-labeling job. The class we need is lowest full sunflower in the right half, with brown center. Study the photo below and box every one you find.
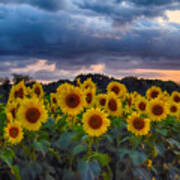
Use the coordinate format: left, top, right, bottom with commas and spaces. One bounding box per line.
127, 112, 150, 136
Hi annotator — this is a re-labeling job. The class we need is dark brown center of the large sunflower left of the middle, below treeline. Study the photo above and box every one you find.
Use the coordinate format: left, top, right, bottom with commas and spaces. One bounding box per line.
66, 94, 80, 108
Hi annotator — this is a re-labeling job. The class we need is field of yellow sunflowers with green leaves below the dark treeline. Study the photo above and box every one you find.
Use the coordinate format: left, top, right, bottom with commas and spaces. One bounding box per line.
0, 78, 180, 180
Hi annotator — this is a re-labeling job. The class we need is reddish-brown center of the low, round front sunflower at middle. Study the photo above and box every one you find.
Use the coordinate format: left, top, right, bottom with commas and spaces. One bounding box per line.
88, 115, 103, 129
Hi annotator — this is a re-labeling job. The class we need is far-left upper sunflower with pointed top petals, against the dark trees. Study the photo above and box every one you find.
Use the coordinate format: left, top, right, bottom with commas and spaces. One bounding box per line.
9, 80, 26, 101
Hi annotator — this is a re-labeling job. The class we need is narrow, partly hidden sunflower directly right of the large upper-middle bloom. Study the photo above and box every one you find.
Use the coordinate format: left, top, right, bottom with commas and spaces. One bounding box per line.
83, 88, 96, 107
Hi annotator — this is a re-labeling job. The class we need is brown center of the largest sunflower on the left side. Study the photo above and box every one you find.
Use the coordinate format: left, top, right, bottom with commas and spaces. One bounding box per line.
26, 107, 41, 123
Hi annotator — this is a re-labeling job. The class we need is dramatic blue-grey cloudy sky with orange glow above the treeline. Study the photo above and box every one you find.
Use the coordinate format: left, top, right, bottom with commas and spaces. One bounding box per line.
0, 0, 180, 82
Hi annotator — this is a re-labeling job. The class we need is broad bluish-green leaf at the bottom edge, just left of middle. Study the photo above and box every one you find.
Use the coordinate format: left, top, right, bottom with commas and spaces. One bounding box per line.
78, 160, 101, 180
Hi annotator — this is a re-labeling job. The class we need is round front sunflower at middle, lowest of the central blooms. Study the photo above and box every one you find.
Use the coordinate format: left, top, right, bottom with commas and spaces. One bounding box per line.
82, 108, 110, 137
